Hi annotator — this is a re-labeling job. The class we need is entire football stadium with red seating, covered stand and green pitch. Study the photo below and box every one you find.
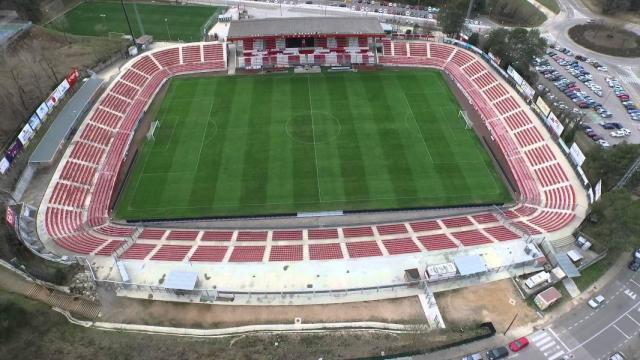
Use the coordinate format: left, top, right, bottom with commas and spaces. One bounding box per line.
38, 18, 587, 304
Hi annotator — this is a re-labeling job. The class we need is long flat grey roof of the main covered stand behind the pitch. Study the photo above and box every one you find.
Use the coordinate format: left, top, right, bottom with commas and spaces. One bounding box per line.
227, 17, 384, 41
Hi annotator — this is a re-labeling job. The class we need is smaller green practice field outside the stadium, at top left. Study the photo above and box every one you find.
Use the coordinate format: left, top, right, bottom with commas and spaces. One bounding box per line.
47, 1, 224, 41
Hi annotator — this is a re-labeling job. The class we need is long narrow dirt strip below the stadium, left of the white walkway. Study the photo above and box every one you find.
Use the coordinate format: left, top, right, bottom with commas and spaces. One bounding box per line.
101, 296, 426, 328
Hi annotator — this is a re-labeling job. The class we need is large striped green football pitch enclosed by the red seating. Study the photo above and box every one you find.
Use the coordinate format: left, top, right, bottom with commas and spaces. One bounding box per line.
116, 70, 511, 219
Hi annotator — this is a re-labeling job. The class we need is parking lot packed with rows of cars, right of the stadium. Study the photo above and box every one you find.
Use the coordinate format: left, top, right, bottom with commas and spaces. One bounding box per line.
535, 45, 640, 147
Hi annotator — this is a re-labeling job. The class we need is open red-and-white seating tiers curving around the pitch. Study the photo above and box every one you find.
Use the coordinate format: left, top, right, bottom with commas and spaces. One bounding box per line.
32, 19, 587, 304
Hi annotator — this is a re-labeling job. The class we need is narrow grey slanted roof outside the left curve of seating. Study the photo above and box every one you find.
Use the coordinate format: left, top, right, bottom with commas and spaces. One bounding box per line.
29, 77, 104, 163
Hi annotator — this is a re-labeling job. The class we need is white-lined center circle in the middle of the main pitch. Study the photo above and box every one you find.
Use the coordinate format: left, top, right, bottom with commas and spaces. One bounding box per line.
285, 111, 342, 144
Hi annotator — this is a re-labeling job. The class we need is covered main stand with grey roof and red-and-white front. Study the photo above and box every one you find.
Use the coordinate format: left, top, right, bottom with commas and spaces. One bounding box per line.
227, 17, 385, 69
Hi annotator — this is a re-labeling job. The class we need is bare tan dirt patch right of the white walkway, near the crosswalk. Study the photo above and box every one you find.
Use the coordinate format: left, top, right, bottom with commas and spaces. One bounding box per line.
436, 279, 538, 332
